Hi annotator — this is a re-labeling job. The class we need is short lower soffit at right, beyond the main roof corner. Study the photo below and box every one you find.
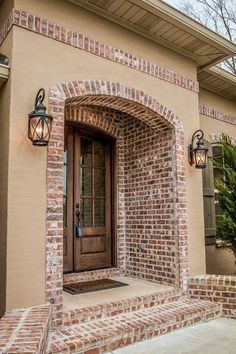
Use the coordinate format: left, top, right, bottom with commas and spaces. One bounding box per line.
198, 67, 236, 102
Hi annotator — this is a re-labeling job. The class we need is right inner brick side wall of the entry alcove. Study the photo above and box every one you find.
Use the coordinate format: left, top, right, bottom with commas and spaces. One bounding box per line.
124, 117, 178, 285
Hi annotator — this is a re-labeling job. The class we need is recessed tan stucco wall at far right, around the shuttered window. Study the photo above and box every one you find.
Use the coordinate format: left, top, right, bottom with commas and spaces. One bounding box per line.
199, 89, 236, 274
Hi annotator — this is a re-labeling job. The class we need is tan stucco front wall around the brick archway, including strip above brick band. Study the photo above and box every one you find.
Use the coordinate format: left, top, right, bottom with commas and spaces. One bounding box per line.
0, 0, 213, 309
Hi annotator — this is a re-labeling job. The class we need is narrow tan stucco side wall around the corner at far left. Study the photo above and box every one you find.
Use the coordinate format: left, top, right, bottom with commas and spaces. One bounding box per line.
0, 33, 12, 317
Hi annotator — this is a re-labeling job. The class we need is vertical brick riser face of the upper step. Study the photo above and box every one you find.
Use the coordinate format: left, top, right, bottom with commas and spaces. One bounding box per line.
63, 293, 184, 327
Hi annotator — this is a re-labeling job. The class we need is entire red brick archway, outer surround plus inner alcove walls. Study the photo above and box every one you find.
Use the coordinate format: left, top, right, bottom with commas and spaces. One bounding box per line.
46, 81, 188, 325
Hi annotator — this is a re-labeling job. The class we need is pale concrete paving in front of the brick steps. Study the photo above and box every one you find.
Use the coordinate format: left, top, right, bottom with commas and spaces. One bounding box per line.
109, 318, 236, 354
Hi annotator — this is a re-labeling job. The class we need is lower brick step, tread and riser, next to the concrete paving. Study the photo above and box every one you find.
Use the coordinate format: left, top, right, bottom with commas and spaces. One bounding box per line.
47, 300, 222, 354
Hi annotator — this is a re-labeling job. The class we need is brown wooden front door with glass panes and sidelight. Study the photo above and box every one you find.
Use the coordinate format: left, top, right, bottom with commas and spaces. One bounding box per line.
64, 127, 112, 272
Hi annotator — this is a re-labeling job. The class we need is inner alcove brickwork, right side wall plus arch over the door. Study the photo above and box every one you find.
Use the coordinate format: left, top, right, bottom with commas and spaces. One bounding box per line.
66, 106, 178, 285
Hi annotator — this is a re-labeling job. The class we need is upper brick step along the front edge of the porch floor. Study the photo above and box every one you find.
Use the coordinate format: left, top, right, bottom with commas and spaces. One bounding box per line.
63, 288, 186, 326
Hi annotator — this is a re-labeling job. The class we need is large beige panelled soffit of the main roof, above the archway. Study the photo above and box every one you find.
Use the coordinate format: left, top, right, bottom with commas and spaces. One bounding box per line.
68, 0, 236, 69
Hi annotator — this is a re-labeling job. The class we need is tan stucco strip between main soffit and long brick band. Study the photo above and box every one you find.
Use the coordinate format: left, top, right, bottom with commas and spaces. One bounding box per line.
15, 0, 196, 80
